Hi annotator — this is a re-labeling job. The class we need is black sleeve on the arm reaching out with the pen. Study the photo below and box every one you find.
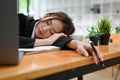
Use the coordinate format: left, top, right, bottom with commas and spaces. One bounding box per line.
52, 36, 72, 50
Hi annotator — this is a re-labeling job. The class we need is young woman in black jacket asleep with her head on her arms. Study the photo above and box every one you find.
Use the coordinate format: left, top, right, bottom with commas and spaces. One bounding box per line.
18, 12, 103, 63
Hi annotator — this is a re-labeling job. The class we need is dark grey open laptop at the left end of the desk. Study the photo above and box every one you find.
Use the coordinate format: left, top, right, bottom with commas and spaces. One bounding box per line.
0, 0, 23, 65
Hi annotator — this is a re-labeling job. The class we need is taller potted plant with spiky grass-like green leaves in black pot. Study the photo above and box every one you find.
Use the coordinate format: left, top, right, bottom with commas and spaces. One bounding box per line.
98, 17, 112, 45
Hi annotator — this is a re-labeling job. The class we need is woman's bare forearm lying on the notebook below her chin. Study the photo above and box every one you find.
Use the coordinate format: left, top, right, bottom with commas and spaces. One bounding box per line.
34, 39, 51, 46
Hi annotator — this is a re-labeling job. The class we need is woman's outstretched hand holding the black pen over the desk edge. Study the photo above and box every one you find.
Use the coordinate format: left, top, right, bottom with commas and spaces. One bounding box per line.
76, 42, 103, 64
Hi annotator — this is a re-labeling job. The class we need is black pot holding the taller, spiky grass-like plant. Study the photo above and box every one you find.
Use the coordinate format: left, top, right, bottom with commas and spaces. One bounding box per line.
99, 34, 110, 45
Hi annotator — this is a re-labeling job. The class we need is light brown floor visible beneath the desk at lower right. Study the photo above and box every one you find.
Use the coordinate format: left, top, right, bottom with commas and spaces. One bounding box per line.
70, 67, 120, 80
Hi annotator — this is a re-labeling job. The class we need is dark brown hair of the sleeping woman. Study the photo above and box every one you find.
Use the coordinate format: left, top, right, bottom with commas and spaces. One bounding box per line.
41, 12, 75, 35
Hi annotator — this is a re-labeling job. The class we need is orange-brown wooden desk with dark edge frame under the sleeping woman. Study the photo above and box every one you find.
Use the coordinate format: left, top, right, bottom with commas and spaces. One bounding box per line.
0, 44, 120, 80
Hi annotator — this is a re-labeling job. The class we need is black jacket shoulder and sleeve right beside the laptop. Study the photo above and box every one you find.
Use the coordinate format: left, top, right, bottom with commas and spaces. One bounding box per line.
18, 13, 37, 48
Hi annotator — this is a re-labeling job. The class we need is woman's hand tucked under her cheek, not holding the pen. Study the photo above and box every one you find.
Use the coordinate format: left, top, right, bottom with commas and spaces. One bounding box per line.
47, 33, 67, 45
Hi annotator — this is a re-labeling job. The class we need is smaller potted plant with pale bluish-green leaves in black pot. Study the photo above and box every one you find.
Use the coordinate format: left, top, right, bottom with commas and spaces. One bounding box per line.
86, 26, 99, 46
